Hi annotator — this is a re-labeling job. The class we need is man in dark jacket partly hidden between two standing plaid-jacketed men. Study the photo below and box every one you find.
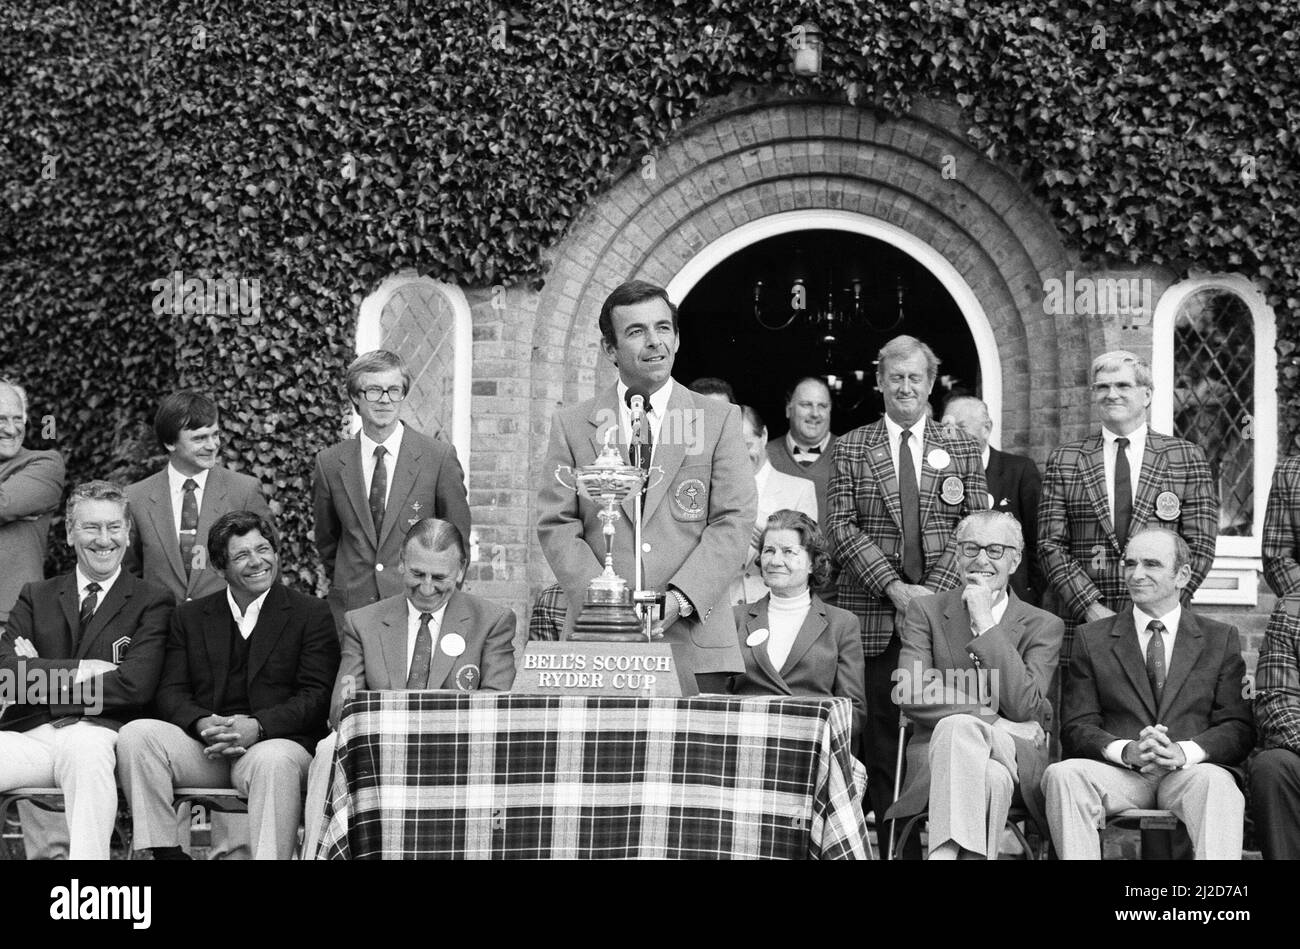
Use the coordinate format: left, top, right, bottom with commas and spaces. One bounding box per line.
943, 395, 1045, 606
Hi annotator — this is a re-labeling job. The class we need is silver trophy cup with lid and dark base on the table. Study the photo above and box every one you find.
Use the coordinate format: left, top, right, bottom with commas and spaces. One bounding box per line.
555, 432, 663, 642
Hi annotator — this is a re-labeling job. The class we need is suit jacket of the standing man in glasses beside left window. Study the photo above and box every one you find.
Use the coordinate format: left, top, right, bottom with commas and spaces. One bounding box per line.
312, 425, 469, 628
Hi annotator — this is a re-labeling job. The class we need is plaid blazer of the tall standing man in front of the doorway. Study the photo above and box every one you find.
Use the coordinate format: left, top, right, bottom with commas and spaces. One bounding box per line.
826, 420, 988, 658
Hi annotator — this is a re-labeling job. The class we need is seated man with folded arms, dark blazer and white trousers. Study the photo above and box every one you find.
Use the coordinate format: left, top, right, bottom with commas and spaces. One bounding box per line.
0, 481, 172, 861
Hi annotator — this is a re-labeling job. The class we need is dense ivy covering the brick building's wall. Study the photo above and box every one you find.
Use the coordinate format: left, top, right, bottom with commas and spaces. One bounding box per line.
0, 0, 1300, 586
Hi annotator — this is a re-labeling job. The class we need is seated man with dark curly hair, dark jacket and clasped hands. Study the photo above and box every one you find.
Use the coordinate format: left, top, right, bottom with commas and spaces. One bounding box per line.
117, 511, 338, 859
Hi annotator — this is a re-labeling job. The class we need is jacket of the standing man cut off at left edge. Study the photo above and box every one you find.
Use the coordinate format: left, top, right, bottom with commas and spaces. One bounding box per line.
0, 449, 64, 629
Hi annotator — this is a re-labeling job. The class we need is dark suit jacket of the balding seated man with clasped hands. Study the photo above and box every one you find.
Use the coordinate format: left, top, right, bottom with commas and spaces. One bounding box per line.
1061, 606, 1255, 780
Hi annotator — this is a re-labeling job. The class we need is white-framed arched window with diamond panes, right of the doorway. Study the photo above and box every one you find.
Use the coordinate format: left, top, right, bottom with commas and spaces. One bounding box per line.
1152, 274, 1278, 605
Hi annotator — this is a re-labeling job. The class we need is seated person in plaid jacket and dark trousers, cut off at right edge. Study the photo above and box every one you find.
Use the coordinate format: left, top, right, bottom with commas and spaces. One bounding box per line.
1251, 595, 1300, 861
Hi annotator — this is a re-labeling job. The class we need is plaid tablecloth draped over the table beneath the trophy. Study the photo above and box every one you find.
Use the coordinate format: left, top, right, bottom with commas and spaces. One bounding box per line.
317, 692, 867, 859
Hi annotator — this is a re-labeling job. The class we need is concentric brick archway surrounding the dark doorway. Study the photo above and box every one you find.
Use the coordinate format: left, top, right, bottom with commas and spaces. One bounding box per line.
529, 100, 1101, 592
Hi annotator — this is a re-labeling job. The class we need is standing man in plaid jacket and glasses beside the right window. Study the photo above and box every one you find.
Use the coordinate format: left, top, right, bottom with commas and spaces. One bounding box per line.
1039, 350, 1218, 663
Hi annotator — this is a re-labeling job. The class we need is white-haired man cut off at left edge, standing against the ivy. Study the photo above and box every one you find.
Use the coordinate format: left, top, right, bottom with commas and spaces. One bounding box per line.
0, 377, 64, 631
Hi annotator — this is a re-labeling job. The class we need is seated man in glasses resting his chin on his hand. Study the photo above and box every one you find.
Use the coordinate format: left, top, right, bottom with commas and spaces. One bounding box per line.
887, 511, 1065, 859
